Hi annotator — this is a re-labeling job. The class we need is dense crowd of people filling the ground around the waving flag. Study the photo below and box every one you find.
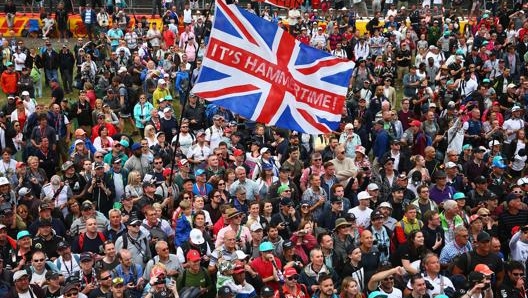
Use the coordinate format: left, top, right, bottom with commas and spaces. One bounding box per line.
0, 0, 528, 298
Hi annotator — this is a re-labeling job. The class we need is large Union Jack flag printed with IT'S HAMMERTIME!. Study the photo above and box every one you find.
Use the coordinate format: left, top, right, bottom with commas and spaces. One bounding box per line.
192, 0, 353, 134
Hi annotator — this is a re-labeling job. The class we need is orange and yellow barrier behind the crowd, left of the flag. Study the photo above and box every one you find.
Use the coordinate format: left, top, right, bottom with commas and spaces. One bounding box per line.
0, 13, 162, 37
